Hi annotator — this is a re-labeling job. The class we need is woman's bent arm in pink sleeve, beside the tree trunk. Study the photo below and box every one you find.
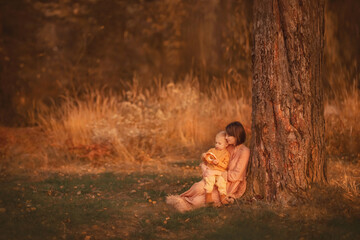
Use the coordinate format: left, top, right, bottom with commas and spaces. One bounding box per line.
227, 148, 250, 182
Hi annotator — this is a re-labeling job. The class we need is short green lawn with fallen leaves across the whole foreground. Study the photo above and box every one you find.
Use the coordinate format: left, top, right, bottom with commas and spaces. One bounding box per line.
0, 161, 360, 239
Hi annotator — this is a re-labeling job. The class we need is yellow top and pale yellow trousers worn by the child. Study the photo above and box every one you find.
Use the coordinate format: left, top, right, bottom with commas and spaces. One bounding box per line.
203, 148, 230, 195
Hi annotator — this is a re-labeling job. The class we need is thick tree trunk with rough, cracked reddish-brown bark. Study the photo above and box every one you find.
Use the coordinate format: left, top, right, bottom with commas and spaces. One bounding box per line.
249, 0, 326, 203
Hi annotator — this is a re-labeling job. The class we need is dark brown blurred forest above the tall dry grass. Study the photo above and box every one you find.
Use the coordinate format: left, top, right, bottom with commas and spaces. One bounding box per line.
0, 0, 360, 126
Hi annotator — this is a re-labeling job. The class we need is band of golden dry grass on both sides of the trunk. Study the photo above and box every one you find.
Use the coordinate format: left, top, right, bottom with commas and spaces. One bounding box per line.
0, 74, 354, 172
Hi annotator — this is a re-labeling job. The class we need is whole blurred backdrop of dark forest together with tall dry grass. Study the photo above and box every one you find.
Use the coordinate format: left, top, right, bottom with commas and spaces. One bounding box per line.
0, 0, 360, 172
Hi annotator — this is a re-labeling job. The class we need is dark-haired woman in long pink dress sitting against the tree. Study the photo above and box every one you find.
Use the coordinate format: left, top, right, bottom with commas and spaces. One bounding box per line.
166, 122, 250, 212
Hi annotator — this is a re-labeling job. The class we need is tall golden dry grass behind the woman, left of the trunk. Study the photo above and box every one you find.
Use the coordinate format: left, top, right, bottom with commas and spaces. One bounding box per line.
26, 76, 251, 166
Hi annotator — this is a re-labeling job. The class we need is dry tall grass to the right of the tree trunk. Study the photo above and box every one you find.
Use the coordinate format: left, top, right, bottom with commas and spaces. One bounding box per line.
324, 78, 360, 204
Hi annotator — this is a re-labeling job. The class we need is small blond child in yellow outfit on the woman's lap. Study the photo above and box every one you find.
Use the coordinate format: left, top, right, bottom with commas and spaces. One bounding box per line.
201, 131, 230, 205
